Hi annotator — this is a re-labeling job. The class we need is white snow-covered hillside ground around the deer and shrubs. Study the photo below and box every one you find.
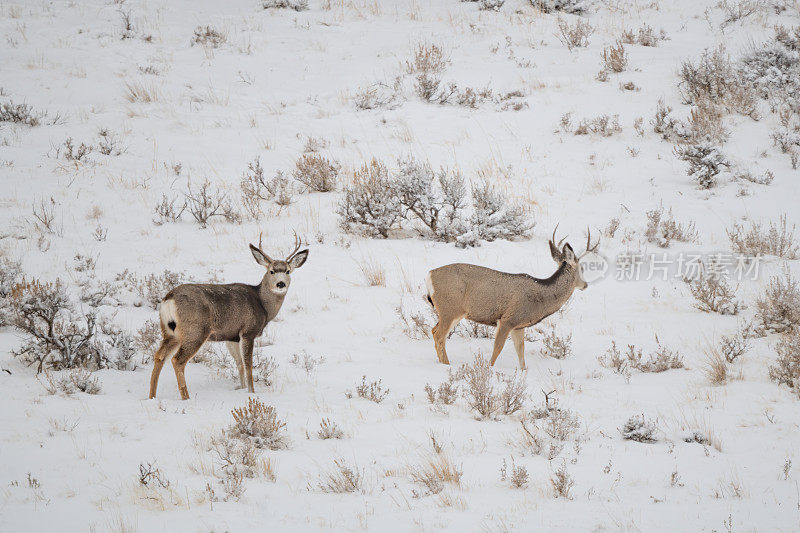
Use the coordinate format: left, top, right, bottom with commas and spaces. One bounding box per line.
0, 0, 800, 532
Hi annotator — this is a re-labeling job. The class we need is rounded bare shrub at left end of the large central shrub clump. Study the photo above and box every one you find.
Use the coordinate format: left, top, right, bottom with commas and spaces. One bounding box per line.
337, 159, 402, 239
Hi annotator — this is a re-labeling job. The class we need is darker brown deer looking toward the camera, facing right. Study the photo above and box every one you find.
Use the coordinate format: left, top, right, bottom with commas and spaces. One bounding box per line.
150, 234, 308, 400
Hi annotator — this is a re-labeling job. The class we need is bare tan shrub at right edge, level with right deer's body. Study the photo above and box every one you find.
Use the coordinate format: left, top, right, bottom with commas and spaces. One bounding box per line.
756, 268, 800, 333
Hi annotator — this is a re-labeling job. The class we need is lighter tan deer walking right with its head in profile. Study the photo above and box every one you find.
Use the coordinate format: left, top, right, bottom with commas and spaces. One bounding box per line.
427, 229, 600, 370
